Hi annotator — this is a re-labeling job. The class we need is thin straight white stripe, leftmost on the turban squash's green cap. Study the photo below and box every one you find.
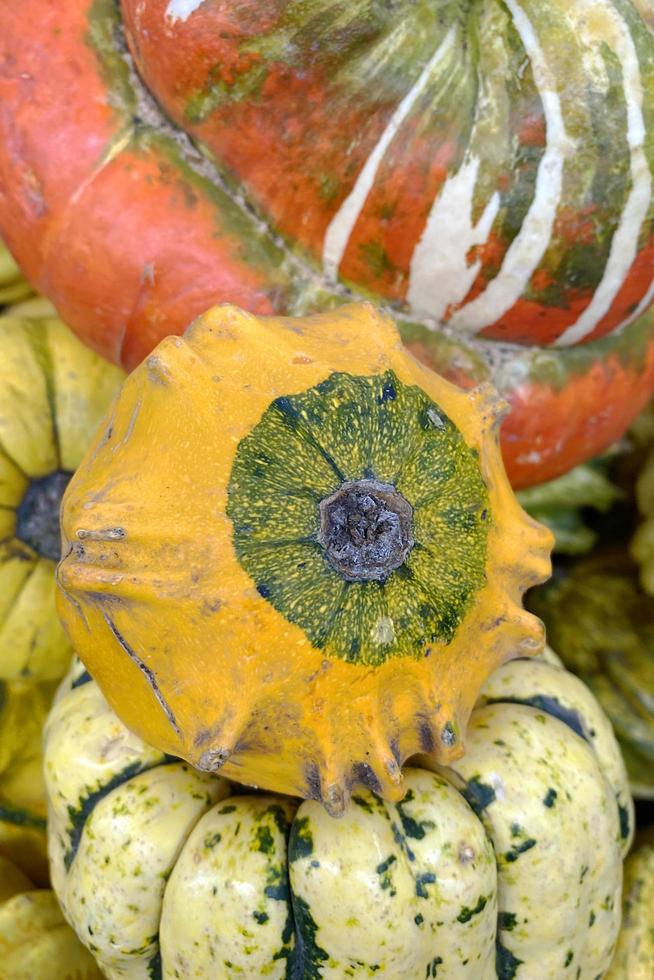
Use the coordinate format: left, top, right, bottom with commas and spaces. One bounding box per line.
322, 27, 456, 282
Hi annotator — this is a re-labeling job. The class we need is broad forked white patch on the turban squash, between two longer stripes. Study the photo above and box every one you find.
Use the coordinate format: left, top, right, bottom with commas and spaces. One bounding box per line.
407, 157, 500, 321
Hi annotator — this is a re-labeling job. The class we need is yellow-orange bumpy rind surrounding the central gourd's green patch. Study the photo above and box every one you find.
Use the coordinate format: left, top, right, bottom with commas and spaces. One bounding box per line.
58, 304, 552, 814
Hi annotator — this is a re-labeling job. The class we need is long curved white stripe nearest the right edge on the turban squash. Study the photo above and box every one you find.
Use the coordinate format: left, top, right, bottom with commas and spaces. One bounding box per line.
555, 0, 652, 347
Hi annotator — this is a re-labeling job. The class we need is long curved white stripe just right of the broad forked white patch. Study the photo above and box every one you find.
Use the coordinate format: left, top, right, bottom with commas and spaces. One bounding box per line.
449, 0, 574, 334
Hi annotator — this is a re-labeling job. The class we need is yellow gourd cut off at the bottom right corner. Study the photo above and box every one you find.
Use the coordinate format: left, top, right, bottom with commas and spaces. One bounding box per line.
606, 831, 654, 980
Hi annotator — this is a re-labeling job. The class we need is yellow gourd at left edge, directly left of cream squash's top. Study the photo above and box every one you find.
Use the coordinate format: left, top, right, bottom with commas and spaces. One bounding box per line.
0, 681, 53, 884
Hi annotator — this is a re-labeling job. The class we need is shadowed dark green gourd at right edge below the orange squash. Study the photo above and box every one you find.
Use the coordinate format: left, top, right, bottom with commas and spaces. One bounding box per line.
528, 551, 654, 799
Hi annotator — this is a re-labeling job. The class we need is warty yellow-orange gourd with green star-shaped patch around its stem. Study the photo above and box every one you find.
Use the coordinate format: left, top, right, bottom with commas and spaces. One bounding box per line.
57, 304, 552, 813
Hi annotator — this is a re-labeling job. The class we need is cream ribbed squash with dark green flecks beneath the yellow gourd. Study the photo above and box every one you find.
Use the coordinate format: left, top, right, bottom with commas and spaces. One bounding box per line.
45, 658, 633, 980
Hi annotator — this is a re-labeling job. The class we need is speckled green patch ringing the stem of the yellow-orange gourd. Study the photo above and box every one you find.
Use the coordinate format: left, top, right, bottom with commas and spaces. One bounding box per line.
227, 371, 490, 665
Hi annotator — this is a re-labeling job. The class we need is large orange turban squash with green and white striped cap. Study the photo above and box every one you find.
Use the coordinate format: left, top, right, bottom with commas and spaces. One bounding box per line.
0, 0, 654, 486
